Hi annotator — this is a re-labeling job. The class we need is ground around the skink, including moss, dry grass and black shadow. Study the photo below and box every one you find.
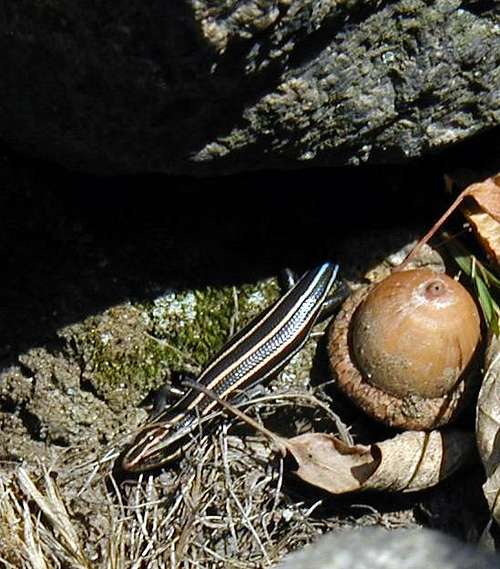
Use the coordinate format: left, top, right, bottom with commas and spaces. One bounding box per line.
0, 134, 495, 568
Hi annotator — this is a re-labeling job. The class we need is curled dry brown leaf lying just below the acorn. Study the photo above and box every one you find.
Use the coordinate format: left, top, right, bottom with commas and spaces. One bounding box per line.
287, 431, 475, 494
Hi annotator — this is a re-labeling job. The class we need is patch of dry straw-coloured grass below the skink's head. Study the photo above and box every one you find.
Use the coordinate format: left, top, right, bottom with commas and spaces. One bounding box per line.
0, 366, 406, 569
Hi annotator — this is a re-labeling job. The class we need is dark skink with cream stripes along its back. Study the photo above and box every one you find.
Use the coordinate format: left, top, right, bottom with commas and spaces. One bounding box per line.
121, 263, 338, 472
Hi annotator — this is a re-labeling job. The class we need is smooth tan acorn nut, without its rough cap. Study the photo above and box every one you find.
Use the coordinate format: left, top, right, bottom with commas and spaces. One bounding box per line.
351, 269, 481, 397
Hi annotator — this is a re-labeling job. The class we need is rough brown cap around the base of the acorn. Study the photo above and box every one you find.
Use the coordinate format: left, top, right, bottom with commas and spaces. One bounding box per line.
328, 269, 479, 430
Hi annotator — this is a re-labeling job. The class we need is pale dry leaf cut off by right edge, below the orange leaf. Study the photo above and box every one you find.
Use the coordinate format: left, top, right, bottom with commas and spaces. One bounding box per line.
476, 336, 500, 523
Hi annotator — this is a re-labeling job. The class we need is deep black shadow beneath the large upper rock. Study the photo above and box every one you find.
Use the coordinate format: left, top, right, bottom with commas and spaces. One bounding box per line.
0, 125, 498, 365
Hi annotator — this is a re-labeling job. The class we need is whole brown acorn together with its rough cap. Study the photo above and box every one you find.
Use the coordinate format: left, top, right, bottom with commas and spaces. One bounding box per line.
328, 269, 481, 430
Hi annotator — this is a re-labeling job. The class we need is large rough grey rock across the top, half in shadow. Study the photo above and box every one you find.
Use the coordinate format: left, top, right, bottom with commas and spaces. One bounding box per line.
0, 0, 500, 175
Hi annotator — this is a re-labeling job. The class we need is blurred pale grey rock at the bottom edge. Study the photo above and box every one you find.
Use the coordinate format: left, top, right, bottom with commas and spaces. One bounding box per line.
276, 528, 500, 569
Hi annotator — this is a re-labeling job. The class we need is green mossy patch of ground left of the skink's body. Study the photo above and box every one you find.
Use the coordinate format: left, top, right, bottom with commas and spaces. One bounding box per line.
61, 281, 279, 409
